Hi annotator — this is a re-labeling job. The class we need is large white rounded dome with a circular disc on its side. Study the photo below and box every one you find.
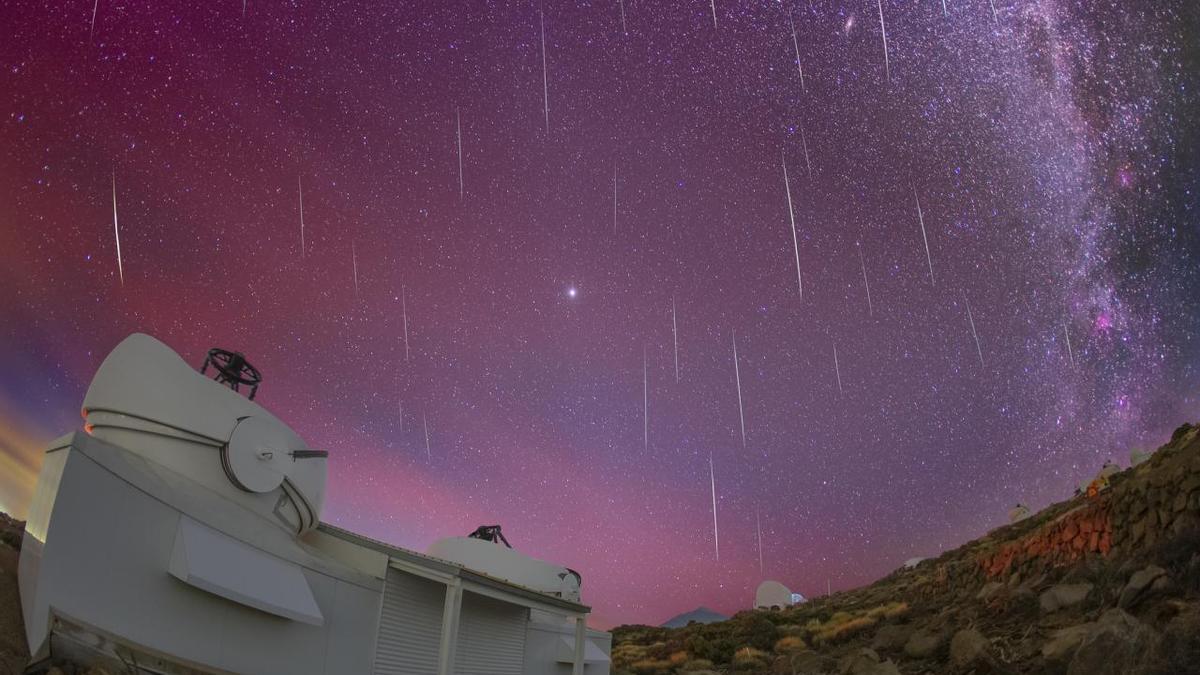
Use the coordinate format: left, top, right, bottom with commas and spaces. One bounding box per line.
83, 333, 326, 534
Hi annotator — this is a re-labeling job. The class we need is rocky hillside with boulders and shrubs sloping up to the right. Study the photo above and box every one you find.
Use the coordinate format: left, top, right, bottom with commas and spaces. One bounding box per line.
613, 425, 1200, 675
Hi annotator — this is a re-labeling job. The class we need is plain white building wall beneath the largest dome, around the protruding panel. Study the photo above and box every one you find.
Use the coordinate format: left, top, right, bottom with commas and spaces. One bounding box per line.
23, 441, 379, 675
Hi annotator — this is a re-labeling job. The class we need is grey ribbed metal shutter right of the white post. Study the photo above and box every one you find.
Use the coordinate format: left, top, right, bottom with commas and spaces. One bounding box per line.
454, 592, 529, 675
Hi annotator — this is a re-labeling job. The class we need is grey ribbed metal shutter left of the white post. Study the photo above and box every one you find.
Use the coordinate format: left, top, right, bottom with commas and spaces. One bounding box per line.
374, 568, 446, 675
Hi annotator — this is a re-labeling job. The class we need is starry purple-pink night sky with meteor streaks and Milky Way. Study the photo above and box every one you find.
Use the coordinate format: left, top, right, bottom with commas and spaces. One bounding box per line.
0, 0, 1200, 625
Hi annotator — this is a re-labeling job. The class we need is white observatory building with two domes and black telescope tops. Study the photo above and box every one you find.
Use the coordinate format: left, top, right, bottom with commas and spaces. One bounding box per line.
18, 334, 612, 675
